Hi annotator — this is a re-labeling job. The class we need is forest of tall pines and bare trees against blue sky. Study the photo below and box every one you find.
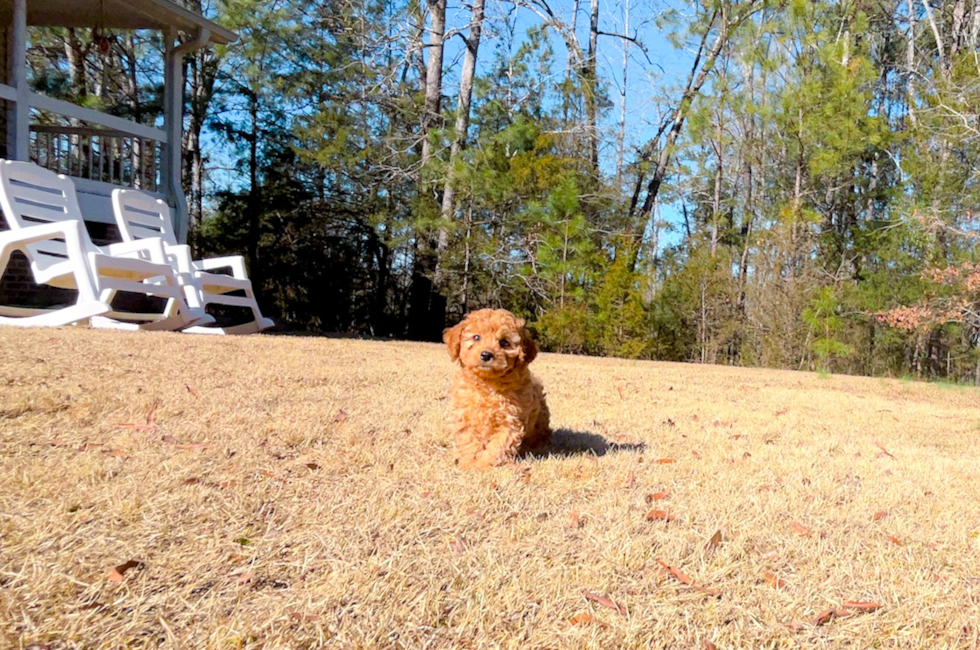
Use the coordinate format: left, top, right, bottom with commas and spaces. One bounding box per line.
23, 0, 980, 382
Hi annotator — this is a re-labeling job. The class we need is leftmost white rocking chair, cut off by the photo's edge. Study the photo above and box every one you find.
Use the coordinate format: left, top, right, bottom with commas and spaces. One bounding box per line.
0, 160, 199, 330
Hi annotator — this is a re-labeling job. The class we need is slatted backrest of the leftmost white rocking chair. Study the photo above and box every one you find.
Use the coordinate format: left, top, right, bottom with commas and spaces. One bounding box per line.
0, 159, 97, 268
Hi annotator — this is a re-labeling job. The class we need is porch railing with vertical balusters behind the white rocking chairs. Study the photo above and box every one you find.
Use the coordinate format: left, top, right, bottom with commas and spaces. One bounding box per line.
28, 124, 164, 192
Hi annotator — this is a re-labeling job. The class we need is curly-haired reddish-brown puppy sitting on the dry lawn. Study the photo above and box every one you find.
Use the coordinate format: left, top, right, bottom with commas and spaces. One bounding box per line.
442, 309, 551, 469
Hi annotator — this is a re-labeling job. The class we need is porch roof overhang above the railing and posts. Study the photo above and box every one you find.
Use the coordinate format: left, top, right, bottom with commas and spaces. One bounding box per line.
0, 0, 238, 43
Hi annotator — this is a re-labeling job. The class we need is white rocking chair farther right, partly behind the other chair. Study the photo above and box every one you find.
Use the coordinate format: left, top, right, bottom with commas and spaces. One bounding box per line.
112, 189, 275, 334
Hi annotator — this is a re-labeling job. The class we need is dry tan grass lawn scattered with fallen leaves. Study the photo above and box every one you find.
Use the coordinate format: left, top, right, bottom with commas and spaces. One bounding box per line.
0, 329, 980, 649
